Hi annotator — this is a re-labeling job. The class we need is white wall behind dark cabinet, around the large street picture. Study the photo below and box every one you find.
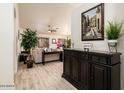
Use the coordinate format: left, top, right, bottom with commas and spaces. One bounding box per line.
71, 3, 124, 89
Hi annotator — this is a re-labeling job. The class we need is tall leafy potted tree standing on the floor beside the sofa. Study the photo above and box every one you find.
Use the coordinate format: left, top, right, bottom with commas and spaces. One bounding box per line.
21, 28, 38, 68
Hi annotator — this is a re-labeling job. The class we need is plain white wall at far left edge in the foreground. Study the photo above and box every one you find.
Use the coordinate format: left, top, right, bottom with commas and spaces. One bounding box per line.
0, 4, 14, 89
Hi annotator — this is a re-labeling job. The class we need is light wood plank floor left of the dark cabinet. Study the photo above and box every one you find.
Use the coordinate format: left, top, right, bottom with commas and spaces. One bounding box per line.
15, 62, 76, 90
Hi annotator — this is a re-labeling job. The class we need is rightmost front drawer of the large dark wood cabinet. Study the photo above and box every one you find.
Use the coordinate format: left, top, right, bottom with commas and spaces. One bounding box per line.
92, 56, 107, 64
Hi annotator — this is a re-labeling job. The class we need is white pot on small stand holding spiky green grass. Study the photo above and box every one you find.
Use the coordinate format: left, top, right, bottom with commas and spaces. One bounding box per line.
108, 40, 118, 52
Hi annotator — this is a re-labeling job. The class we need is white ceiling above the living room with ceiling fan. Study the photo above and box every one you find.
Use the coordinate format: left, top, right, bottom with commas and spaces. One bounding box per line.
18, 3, 81, 35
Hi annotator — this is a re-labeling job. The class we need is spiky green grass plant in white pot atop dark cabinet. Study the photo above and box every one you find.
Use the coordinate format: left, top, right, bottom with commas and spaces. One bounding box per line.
106, 22, 123, 52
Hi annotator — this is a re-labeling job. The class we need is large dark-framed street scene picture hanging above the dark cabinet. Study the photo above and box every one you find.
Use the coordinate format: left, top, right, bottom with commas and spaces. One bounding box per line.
81, 3, 104, 41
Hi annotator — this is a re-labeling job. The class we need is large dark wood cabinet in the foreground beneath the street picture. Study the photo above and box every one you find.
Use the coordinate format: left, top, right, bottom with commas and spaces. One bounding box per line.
62, 49, 121, 90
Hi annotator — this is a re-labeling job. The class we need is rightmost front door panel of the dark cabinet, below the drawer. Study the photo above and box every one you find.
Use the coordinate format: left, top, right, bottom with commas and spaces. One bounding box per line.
90, 64, 107, 90
